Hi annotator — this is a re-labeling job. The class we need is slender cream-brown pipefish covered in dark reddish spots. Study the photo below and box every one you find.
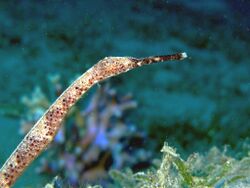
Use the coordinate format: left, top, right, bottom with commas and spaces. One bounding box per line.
0, 53, 186, 188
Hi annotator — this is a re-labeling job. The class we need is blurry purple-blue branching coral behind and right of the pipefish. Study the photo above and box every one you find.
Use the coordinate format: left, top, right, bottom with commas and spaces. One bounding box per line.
35, 84, 151, 186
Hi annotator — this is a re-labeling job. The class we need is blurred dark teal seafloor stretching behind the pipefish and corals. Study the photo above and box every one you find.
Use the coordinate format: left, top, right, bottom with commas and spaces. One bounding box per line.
0, 0, 250, 187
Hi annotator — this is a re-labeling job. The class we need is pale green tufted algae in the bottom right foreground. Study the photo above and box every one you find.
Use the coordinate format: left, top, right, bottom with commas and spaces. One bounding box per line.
44, 140, 250, 188
